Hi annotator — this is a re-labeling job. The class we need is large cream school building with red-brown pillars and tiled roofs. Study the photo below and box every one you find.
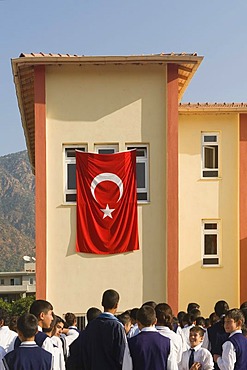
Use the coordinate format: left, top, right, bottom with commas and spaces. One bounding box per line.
12, 54, 247, 314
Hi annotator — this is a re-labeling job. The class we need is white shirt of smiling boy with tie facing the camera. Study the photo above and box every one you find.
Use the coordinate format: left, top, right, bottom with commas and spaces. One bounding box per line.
178, 344, 214, 370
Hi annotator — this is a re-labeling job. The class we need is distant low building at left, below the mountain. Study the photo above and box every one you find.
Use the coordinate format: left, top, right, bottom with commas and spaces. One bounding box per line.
0, 263, 36, 302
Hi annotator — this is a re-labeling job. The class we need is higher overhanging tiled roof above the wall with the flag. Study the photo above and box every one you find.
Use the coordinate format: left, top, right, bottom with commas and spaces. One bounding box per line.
12, 53, 203, 170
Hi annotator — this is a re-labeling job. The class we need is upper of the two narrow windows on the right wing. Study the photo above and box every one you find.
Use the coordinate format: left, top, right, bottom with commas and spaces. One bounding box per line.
202, 132, 219, 177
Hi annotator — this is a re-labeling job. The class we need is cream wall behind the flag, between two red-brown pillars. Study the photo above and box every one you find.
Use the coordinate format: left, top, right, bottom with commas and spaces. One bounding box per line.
46, 66, 166, 314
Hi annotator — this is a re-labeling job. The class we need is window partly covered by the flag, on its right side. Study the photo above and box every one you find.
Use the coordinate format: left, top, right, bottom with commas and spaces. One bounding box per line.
127, 145, 149, 202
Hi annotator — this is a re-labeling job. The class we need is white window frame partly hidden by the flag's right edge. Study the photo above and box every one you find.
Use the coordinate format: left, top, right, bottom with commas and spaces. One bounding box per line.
126, 143, 150, 204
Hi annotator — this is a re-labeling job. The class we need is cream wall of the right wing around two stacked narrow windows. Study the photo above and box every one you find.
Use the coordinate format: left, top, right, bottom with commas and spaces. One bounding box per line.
179, 113, 239, 315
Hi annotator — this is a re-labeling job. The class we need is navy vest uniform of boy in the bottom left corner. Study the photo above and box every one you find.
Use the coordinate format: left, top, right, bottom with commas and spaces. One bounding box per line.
3, 341, 52, 370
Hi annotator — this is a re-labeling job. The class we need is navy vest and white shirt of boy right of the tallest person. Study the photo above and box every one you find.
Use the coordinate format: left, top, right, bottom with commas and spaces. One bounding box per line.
123, 327, 177, 370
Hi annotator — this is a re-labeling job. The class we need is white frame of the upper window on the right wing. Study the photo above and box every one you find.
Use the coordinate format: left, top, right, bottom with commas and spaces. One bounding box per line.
201, 131, 220, 180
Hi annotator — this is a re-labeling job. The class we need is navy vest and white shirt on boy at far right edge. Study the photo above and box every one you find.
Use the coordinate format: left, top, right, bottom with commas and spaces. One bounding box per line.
217, 330, 247, 370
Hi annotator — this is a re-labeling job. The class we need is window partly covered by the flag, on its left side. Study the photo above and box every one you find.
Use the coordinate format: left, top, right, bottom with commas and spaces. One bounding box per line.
64, 145, 87, 203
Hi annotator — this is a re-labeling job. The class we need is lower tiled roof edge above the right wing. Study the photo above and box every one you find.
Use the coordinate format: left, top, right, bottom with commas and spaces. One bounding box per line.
178, 103, 247, 114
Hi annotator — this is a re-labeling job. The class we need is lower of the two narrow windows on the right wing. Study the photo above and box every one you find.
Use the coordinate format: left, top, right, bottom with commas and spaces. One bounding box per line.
202, 220, 220, 266
